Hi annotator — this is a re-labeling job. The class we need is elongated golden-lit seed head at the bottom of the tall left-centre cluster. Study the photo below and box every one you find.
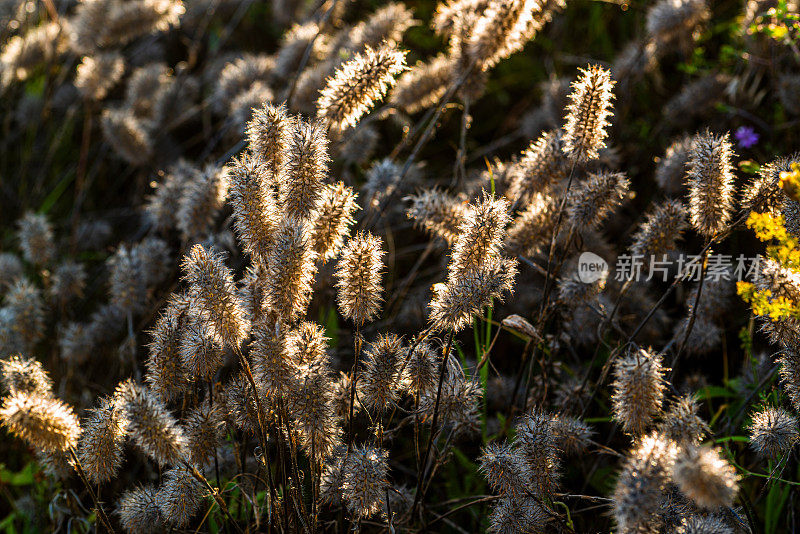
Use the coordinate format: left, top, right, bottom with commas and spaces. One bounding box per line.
265, 218, 317, 322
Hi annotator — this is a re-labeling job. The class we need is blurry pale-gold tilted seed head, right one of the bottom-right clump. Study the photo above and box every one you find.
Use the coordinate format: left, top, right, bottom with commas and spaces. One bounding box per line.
672, 446, 738, 510
